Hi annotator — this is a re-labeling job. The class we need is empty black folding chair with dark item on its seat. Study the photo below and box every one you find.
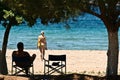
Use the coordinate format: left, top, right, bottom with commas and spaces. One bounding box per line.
44, 55, 66, 75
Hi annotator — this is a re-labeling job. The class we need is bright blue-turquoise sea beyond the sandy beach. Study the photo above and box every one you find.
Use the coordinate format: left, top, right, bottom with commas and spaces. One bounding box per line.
0, 14, 120, 50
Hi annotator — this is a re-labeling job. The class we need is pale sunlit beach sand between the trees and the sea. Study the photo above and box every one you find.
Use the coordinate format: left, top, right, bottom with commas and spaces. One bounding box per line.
6, 49, 107, 76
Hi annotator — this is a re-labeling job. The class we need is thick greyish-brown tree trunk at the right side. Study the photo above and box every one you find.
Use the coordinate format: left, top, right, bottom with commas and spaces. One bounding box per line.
107, 26, 119, 77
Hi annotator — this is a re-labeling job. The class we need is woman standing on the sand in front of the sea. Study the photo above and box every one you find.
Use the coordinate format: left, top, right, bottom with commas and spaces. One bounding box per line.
37, 31, 47, 60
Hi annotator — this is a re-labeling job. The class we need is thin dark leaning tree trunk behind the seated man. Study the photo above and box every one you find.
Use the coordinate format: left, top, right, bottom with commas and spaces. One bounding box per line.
0, 24, 11, 75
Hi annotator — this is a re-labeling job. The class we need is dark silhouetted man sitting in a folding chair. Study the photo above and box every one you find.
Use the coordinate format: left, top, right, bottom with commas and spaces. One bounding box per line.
12, 42, 36, 75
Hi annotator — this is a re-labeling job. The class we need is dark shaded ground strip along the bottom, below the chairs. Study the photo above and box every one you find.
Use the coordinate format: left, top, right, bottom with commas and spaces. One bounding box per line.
16, 73, 120, 80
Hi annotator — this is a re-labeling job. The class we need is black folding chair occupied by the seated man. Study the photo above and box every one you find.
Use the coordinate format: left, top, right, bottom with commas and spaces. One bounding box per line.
11, 56, 34, 75
